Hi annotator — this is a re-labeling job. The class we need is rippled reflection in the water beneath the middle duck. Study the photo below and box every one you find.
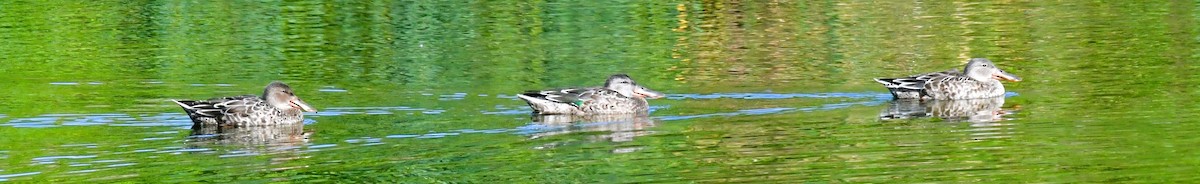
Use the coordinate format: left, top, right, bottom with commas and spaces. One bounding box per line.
529, 113, 655, 153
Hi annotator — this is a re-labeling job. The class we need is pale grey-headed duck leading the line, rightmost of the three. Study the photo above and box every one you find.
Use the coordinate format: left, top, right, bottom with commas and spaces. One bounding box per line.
875, 58, 1021, 100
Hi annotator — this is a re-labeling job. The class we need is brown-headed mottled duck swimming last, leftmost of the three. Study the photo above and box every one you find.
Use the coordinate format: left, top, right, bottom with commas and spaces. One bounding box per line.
172, 82, 317, 126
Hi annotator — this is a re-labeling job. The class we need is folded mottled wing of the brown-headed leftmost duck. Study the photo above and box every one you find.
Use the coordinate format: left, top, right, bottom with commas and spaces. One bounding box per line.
175, 95, 263, 117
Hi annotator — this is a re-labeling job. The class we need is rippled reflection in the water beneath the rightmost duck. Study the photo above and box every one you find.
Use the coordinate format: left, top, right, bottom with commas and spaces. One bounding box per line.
880, 96, 1012, 123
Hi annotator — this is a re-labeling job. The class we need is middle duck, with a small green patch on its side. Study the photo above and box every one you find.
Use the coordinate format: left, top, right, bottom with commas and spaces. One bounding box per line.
517, 73, 666, 115
